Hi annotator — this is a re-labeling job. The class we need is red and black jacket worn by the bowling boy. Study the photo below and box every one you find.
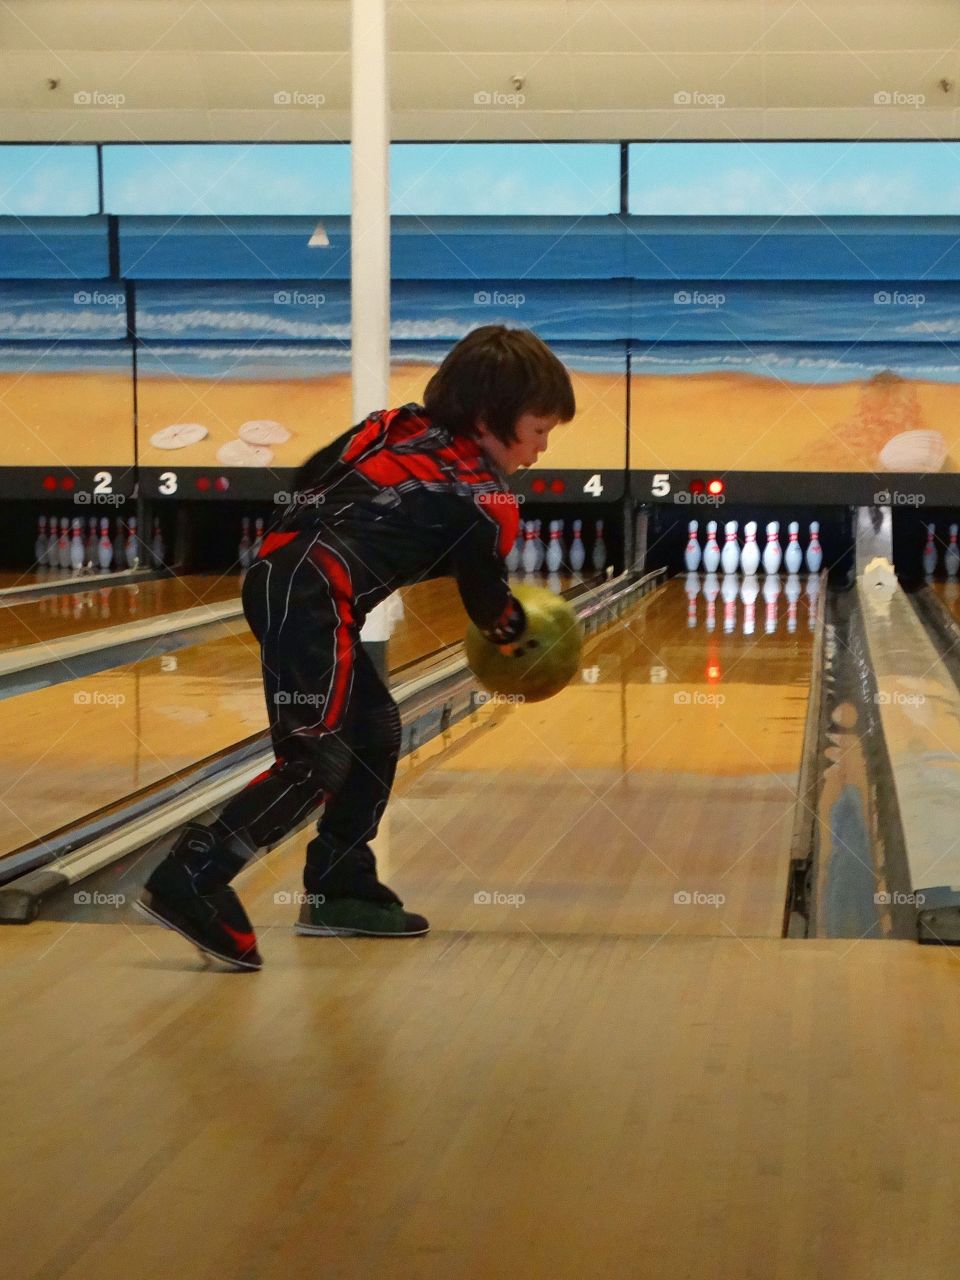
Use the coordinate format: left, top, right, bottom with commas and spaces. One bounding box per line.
261, 404, 524, 644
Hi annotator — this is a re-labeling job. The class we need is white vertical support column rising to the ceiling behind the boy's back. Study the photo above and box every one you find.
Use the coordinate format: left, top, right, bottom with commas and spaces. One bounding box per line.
349, 0, 390, 422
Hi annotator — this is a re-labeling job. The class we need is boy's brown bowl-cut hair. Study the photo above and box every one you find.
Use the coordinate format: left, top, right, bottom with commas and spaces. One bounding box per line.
424, 324, 576, 444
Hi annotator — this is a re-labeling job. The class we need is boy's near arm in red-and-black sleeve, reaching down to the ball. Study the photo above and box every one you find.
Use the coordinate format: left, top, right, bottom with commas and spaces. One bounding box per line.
451, 493, 526, 644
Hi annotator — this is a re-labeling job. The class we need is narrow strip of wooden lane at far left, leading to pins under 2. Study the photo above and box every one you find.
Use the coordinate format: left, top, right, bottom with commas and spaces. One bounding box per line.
0, 573, 239, 650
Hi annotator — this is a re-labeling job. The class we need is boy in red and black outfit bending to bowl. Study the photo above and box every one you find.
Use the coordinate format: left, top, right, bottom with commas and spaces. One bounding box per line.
137, 325, 576, 970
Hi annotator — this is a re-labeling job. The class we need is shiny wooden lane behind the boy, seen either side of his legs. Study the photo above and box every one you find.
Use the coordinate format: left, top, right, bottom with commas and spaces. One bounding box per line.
0, 579, 570, 858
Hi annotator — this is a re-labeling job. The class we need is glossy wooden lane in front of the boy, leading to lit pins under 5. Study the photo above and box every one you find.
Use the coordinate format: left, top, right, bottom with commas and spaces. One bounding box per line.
246, 580, 818, 947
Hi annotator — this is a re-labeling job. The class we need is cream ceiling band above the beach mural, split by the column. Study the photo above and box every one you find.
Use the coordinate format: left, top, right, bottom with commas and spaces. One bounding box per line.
0, 0, 960, 142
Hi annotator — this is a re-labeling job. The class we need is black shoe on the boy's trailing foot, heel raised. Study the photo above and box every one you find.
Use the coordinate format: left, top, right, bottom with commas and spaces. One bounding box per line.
133, 833, 264, 970
